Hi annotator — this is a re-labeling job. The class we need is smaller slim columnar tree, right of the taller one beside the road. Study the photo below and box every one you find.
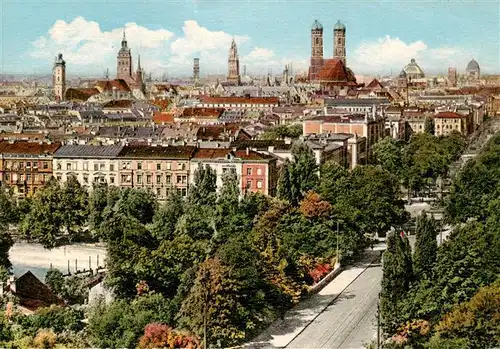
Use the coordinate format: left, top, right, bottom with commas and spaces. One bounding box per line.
413, 211, 437, 278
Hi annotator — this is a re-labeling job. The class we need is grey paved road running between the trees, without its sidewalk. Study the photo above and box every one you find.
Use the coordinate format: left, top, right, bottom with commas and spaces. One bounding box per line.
287, 256, 382, 349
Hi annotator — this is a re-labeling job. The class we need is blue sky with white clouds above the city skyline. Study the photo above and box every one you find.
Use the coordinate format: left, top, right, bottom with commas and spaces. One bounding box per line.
0, 0, 500, 77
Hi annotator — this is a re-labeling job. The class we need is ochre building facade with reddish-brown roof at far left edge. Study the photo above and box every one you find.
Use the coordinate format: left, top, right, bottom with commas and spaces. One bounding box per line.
0, 141, 61, 197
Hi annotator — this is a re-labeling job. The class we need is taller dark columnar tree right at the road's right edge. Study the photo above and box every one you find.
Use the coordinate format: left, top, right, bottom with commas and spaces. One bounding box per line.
380, 232, 413, 333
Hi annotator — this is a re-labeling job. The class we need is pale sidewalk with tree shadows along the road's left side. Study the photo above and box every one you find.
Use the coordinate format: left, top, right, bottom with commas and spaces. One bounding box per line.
244, 244, 385, 348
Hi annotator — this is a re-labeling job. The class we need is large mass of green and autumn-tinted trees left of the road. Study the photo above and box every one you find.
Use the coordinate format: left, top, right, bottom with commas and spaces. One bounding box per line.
0, 145, 407, 348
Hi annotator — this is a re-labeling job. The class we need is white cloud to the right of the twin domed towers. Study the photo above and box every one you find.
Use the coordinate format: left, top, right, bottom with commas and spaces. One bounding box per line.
348, 35, 473, 74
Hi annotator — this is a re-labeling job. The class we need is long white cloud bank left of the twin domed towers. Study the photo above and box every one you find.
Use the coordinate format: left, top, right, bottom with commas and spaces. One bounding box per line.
29, 17, 307, 76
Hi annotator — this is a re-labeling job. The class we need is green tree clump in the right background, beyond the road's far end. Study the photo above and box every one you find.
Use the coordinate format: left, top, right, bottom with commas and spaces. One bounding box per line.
374, 132, 466, 193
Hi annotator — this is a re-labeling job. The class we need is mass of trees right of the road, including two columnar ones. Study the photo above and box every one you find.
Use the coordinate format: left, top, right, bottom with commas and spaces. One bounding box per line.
381, 135, 500, 348
